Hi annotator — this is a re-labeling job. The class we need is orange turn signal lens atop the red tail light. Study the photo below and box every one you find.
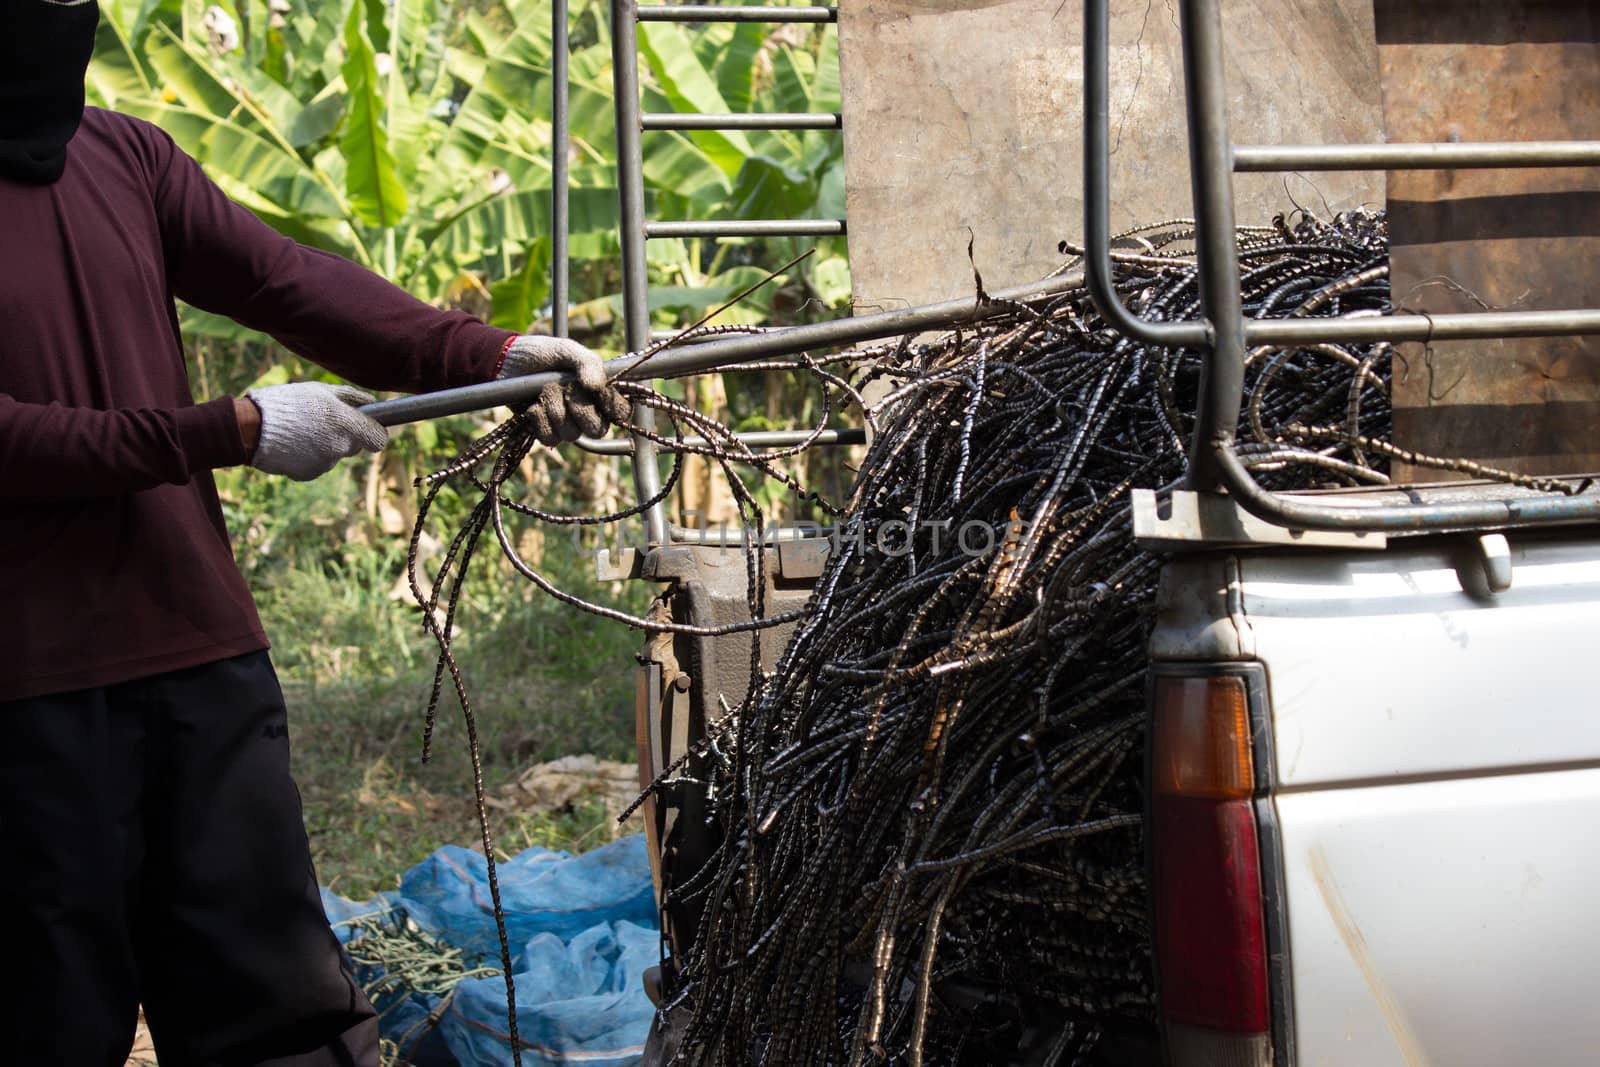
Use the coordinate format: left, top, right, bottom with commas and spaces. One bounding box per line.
1150, 675, 1256, 800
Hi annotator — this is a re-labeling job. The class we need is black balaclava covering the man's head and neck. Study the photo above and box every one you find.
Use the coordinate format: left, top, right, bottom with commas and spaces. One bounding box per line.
0, 0, 99, 186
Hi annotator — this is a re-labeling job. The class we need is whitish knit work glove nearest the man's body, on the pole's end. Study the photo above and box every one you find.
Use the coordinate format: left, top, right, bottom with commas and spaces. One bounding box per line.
245, 382, 389, 482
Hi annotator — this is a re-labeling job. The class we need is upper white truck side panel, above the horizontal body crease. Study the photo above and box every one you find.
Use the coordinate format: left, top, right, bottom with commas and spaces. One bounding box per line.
1240, 536, 1600, 790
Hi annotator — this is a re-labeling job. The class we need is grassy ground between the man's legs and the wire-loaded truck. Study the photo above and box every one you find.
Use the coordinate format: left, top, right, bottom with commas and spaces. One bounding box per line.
222, 464, 650, 899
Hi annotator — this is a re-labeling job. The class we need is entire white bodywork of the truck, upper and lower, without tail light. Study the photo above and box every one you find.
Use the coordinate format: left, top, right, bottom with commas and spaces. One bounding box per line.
1152, 533, 1600, 1067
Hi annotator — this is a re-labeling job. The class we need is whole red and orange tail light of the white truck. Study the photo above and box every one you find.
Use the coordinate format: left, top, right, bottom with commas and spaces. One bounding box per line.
1150, 673, 1272, 1067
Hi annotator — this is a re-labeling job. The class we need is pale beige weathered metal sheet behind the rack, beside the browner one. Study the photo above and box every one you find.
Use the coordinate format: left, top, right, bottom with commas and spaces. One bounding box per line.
838, 0, 1382, 310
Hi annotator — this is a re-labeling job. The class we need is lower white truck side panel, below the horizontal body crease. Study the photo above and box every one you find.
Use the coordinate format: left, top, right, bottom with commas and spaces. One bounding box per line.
1277, 769, 1600, 1067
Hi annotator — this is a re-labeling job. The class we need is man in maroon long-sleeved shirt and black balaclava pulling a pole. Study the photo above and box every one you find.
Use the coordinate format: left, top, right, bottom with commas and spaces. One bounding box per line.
0, 0, 621, 1067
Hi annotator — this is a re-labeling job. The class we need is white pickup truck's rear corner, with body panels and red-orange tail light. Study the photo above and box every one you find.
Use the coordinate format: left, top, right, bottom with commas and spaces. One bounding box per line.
1150, 486, 1600, 1067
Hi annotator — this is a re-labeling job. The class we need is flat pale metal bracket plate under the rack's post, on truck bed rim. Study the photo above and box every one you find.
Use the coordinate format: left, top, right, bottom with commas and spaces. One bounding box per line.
1133, 490, 1387, 552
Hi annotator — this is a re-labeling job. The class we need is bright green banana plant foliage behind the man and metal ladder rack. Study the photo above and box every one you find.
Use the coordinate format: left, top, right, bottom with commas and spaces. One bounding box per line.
90, 0, 848, 339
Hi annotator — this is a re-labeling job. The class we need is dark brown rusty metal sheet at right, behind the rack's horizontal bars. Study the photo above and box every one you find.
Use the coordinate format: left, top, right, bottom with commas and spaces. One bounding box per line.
1374, 0, 1600, 482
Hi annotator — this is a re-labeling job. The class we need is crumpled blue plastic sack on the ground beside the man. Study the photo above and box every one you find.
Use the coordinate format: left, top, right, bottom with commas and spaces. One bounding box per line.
323, 835, 661, 1067
